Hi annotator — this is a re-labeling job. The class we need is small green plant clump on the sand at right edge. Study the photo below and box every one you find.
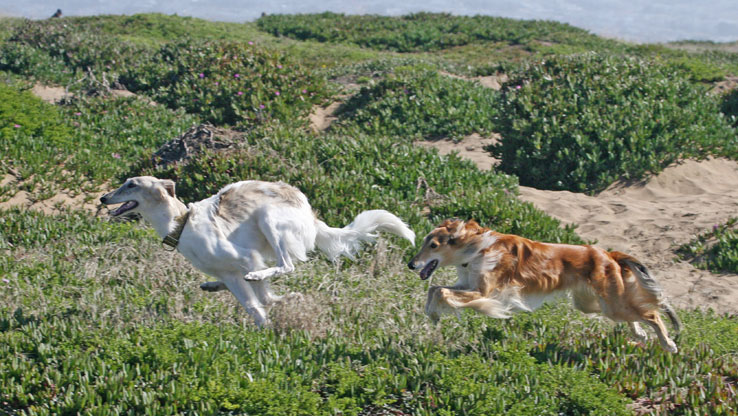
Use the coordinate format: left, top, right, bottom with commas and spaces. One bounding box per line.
677, 218, 738, 273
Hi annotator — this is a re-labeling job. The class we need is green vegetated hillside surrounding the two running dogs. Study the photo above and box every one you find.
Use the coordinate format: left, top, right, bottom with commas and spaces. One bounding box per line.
0, 14, 738, 415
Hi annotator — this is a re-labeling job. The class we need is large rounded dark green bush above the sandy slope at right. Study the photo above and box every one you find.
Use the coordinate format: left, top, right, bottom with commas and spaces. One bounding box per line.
489, 54, 736, 192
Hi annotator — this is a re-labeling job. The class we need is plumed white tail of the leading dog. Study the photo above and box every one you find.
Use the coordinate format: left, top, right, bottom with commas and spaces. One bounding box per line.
315, 209, 415, 260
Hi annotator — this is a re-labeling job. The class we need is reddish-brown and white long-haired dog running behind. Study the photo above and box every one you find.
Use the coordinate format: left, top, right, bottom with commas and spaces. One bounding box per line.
408, 220, 680, 353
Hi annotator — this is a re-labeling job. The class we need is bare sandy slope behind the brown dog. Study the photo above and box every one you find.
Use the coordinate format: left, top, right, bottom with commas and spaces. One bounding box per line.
520, 159, 738, 314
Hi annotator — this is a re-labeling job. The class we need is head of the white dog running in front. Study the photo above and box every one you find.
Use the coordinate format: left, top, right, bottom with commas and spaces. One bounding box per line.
100, 176, 175, 217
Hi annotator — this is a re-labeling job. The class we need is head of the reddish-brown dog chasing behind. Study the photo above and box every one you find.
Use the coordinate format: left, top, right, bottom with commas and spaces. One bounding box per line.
408, 219, 493, 280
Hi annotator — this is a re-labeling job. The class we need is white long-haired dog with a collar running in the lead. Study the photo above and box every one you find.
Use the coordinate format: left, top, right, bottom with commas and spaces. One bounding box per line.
100, 176, 415, 326
